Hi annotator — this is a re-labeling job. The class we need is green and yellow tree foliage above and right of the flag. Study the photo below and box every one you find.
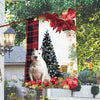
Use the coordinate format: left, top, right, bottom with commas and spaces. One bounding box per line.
5, 0, 100, 73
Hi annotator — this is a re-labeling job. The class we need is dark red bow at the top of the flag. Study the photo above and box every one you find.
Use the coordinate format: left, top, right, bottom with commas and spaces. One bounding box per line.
42, 13, 76, 33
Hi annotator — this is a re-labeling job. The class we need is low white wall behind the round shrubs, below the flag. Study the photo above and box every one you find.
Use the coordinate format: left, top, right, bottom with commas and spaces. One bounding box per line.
47, 85, 100, 98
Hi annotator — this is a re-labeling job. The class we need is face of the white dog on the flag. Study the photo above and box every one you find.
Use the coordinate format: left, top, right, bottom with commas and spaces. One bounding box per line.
31, 49, 42, 61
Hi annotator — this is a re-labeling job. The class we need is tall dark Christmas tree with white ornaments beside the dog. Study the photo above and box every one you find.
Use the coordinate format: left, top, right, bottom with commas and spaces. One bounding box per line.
41, 31, 60, 78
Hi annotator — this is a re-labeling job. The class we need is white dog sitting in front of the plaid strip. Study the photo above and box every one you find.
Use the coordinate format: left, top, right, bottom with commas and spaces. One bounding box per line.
29, 49, 50, 82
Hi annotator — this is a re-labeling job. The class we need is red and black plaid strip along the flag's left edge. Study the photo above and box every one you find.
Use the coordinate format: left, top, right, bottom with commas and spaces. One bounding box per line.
25, 18, 39, 82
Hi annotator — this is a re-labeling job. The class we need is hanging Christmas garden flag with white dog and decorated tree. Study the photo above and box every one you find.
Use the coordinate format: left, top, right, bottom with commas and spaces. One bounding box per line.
25, 9, 78, 89
